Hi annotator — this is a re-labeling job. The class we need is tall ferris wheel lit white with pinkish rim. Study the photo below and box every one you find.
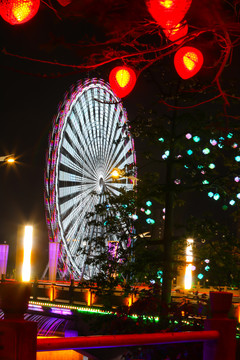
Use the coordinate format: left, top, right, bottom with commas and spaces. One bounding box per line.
45, 79, 136, 279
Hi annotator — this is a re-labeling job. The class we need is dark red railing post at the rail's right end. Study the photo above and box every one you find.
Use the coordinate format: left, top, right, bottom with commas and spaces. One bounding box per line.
203, 291, 236, 360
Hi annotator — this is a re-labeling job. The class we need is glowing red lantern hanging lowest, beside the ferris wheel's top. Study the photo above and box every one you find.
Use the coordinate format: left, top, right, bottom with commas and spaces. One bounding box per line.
109, 66, 136, 98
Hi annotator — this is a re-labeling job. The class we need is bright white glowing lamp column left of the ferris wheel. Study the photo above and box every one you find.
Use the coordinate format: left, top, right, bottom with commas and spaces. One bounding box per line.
22, 226, 33, 282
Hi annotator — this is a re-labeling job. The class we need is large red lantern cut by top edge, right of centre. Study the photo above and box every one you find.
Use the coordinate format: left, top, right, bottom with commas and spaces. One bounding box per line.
147, 0, 192, 29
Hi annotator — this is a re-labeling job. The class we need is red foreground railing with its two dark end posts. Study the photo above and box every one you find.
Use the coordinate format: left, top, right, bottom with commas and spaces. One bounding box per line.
0, 284, 236, 360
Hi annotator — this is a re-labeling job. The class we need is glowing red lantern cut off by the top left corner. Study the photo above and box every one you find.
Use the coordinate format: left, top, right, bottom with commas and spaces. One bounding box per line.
0, 0, 40, 25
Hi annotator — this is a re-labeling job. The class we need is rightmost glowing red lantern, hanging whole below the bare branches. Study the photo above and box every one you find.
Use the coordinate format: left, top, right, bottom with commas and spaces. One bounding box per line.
174, 46, 203, 79
